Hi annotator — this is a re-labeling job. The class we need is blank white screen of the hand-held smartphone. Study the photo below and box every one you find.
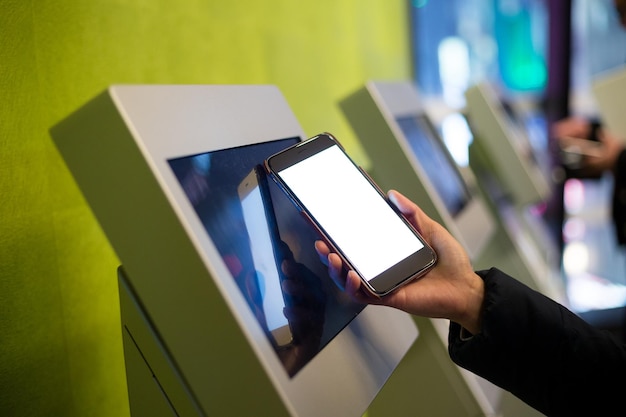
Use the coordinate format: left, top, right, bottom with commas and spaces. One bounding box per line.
279, 146, 424, 281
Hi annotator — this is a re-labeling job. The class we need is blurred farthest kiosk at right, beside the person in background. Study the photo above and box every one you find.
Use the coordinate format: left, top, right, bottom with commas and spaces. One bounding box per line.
465, 83, 568, 305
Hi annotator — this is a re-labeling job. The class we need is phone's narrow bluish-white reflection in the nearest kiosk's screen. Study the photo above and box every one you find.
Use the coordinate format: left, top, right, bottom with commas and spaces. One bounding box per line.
237, 165, 293, 347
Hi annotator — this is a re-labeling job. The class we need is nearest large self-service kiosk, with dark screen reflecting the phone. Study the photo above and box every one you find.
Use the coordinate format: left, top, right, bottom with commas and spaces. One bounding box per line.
51, 85, 420, 416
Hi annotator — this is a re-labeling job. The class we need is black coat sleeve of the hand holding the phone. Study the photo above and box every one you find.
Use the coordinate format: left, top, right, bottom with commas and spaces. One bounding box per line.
449, 269, 626, 416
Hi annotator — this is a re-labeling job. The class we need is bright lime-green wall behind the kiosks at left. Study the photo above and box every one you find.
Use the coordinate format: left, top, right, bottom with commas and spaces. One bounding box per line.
0, 0, 411, 417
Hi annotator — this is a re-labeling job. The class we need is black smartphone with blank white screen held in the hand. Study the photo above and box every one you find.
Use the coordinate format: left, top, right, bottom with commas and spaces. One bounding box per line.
265, 133, 437, 297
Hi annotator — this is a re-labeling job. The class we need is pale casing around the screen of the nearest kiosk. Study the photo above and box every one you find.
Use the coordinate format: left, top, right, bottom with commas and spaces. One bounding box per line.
51, 85, 417, 416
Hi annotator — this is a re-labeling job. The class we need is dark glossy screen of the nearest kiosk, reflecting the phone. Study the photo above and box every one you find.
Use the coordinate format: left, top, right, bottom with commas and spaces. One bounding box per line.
168, 138, 363, 376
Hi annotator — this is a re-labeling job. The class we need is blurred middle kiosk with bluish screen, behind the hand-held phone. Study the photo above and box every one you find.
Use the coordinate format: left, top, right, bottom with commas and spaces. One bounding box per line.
340, 81, 539, 416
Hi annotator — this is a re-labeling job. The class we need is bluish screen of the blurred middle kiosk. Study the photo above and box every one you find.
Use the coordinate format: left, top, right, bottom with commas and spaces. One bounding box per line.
396, 116, 470, 216
